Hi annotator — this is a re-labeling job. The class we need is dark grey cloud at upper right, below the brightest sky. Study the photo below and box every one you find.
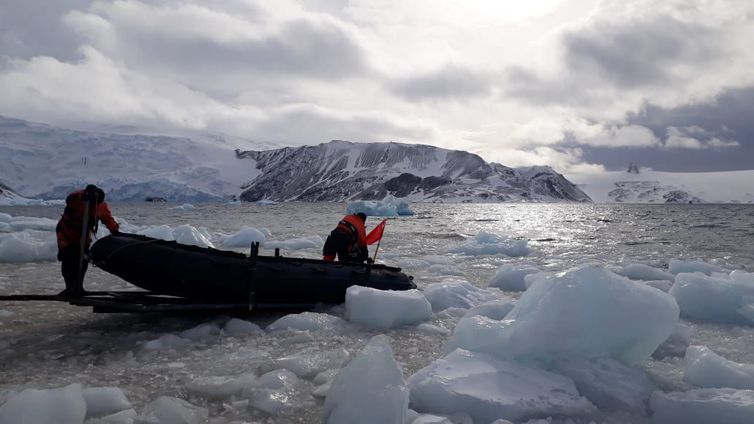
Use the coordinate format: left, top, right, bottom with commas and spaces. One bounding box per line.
563, 16, 721, 88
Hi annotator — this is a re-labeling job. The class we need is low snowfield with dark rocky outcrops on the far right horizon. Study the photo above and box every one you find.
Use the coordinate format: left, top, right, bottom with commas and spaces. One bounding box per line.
568, 169, 754, 203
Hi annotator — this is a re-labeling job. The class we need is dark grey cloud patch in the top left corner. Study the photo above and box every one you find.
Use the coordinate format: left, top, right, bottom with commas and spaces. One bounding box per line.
0, 0, 91, 60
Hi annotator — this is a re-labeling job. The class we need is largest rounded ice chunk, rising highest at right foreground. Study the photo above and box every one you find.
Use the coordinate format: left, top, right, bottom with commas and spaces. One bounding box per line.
446, 266, 679, 365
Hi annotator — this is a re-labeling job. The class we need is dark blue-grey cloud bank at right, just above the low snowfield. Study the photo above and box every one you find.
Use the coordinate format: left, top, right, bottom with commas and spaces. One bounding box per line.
584, 87, 754, 171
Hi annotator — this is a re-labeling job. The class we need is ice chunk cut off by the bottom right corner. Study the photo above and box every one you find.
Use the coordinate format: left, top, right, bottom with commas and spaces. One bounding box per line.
650, 389, 754, 424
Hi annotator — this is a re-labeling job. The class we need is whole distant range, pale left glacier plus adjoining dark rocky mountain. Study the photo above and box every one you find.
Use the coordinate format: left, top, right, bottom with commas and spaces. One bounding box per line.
0, 117, 591, 202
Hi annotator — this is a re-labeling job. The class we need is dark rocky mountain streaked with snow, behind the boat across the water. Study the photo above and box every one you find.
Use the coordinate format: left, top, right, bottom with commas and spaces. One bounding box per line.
237, 141, 591, 202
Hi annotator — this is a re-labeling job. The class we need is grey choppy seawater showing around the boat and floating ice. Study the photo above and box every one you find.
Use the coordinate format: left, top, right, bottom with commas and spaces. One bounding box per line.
0, 203, 754, 423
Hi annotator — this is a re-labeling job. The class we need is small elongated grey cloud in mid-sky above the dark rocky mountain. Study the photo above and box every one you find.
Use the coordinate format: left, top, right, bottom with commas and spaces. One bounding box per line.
388, 66, 491, 101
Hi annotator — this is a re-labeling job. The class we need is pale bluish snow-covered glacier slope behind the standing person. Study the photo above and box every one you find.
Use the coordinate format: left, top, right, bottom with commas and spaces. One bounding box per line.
0, 117, 251, 202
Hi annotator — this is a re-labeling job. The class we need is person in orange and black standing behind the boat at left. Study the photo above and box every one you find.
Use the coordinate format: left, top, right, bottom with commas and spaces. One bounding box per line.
55, 184, 118, 295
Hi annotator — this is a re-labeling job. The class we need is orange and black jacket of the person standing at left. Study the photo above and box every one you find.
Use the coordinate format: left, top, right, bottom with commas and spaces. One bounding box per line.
55, 190, 119, 250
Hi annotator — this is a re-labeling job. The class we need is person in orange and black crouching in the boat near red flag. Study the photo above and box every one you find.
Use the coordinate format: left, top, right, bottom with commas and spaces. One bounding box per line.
322, 212, 369, 262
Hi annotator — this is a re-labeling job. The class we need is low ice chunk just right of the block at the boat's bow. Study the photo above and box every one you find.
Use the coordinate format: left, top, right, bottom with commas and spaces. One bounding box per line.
424, 280, 508, 313
